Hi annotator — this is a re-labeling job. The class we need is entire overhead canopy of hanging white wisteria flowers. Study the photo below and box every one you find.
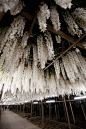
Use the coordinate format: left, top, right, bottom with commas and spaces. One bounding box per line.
0, 0, 86, 104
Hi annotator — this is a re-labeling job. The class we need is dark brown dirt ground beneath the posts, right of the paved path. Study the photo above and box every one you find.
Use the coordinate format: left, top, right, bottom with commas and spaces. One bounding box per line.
11, 109, 86, 129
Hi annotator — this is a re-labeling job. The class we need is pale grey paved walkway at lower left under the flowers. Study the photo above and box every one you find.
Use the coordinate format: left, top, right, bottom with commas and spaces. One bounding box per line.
0, 110, 40, 129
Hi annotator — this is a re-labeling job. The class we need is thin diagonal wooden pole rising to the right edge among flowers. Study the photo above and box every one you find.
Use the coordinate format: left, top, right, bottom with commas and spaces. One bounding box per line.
44, 33, 86, 70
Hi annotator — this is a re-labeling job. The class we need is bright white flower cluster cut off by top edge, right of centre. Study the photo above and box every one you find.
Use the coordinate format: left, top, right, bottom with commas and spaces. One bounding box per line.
55, 0, 72, 9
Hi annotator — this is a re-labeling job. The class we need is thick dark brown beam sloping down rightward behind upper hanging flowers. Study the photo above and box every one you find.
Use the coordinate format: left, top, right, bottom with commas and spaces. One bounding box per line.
20, 10, 85, 50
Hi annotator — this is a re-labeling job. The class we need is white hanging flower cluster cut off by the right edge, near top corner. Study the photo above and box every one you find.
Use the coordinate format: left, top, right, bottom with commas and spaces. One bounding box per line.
72, 8, 86, 31
